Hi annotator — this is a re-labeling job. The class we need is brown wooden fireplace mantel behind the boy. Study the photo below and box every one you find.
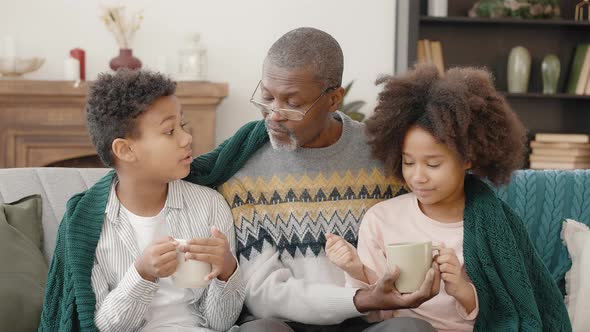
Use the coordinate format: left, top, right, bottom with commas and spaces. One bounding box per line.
0, 80, 228, 168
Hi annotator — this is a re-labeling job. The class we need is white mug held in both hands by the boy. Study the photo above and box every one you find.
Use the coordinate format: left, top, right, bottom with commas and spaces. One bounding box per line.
172, 239, 211, 288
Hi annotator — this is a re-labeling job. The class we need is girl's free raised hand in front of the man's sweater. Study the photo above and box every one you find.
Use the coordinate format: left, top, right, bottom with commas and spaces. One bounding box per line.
325, 233, 366, 282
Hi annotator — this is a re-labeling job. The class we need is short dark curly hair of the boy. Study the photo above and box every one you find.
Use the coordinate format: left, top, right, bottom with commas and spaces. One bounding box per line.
86, 69, 176, 167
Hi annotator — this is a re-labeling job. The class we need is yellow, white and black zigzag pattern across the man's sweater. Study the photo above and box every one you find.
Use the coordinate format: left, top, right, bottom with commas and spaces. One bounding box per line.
219, 169, 406, 259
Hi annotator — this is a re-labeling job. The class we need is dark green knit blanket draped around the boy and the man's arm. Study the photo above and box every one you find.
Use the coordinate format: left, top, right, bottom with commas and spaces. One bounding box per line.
39, 121, 268, 332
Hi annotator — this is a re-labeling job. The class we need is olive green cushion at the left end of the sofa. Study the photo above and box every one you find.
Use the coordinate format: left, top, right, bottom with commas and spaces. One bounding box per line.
0, 195, 48, 331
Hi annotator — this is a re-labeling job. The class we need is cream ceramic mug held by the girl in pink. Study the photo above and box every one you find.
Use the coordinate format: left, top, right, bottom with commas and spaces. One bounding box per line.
386, 241, 440, 293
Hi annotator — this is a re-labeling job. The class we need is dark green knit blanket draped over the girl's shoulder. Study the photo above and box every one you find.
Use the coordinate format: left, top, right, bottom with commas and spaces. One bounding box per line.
463, 175, 572, 332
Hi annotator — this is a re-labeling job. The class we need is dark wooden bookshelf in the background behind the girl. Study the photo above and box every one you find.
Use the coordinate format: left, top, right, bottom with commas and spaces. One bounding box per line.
395, 0, 590, 135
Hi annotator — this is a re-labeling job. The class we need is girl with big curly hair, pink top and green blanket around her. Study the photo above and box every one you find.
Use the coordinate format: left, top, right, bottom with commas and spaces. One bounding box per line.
326, 65, 571, 331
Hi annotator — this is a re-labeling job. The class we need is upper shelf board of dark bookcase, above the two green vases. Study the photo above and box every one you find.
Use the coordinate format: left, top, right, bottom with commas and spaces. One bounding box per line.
420, 16, 590, 27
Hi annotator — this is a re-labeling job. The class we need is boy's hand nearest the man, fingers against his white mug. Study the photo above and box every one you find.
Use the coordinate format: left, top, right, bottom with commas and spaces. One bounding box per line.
180, 226, 237, 281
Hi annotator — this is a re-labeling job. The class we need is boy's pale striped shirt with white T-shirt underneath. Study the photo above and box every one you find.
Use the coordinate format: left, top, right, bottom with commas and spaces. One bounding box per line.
92, 180, 244, 331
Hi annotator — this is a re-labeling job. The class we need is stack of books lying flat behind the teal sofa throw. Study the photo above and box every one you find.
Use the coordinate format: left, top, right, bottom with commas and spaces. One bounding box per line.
530, 133, 590, 169
